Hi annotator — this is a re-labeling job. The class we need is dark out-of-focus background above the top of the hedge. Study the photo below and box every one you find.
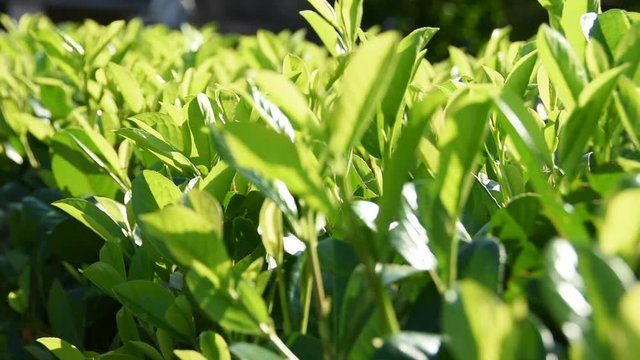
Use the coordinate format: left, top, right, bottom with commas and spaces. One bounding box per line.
0, 0, 640, 60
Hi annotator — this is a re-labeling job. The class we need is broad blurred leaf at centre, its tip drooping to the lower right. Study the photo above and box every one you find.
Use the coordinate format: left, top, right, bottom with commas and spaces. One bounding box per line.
214, 123, 332, 215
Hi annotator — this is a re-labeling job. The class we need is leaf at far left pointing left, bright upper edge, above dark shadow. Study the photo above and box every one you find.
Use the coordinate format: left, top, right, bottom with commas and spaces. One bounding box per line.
53, 199, 128, 247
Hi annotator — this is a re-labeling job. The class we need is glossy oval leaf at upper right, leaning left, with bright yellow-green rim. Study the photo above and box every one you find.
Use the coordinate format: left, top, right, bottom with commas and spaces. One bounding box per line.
536, 25, 587, 110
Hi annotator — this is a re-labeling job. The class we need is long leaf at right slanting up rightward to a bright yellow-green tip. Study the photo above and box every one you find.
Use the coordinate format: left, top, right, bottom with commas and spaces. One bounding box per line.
558, 66, 625, 180
